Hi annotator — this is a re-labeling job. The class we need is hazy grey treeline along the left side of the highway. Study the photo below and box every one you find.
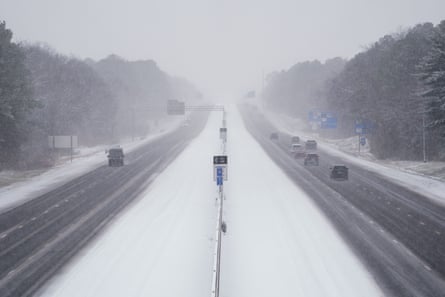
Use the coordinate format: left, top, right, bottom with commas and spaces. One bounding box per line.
0, 22, 201, 170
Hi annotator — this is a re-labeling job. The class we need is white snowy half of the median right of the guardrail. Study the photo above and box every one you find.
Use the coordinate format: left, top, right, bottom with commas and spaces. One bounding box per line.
221, 107, 382, 297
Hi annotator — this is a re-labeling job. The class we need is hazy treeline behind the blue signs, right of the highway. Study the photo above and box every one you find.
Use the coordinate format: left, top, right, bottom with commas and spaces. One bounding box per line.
264, 21, 445, 160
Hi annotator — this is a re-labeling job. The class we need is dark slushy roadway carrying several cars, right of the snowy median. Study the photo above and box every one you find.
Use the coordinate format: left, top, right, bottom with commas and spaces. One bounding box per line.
242, 106, 445, 297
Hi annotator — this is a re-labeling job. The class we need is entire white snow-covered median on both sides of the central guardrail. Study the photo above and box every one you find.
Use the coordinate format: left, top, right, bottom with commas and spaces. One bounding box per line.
39, 109, 383, 297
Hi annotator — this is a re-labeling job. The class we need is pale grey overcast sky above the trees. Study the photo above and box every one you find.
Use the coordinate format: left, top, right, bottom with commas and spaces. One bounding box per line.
0, 0, 445, 95
